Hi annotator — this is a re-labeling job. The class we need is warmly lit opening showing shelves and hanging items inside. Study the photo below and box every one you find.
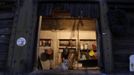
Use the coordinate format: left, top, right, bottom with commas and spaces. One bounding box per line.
37, 10, 99, 70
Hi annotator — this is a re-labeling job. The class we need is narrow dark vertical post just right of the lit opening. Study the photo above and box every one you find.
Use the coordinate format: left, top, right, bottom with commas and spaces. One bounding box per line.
100, 0, 113, 73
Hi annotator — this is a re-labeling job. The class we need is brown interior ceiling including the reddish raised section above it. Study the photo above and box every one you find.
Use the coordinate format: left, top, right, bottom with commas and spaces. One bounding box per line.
41, 10, 96, 31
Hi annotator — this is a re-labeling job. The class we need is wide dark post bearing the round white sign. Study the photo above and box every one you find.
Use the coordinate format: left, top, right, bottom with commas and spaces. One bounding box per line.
8, 0, 37, 72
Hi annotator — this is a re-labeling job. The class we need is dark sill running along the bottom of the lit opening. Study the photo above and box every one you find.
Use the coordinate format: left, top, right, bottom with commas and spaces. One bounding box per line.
31, 69, 102, 75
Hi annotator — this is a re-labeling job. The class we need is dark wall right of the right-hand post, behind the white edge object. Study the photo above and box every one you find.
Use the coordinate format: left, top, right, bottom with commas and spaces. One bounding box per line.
109, 4, 134, 72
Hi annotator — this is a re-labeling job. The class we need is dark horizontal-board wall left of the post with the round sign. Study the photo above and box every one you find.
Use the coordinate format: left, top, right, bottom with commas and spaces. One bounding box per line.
0, 2, 14, 71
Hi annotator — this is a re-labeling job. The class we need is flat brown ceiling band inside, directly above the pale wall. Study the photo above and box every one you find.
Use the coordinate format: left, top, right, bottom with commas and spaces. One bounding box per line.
41, 18, 96, 31
